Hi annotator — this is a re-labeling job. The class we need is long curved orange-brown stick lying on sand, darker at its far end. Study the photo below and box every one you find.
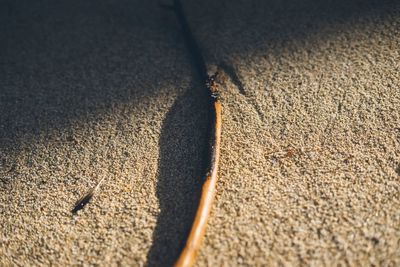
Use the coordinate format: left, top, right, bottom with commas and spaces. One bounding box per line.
169, 0, 222, 267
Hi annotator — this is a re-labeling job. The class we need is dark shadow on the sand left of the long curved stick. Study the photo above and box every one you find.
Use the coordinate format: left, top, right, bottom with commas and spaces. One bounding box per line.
147, 84, 208, 266
